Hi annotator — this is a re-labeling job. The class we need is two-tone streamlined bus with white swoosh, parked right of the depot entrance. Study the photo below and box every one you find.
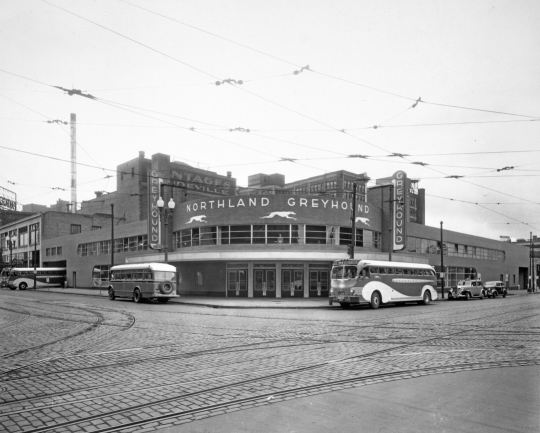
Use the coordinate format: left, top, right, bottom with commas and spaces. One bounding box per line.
329, 259, 437, 309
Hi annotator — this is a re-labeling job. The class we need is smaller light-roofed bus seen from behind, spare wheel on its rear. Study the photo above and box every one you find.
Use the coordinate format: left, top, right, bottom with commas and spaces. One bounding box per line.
108, 263, 179, 304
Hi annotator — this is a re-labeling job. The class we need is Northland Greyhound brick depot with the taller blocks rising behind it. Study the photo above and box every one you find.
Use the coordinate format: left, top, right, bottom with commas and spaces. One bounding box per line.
0, 152, 529, 298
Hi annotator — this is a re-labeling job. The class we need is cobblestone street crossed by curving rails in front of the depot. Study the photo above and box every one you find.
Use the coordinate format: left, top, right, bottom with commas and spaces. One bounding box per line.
0, 290, 540, 432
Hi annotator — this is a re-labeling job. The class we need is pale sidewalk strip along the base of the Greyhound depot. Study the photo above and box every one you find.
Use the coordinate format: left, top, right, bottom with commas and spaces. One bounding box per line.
2, 287, 540, 309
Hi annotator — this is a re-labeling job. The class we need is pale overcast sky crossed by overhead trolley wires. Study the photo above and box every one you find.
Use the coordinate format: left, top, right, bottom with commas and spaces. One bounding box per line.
0, 0, 540, 240
